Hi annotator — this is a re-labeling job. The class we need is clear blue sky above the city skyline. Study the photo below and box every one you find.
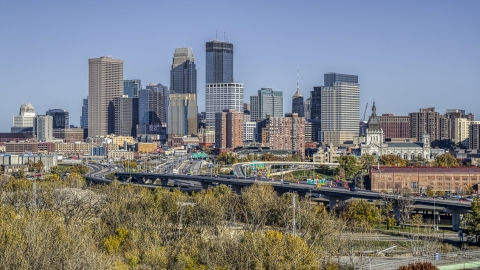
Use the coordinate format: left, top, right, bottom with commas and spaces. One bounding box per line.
0, 0, 480, 131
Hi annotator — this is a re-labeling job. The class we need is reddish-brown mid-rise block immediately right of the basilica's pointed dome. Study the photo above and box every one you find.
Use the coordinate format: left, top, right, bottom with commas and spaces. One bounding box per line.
378, 113, 410, 139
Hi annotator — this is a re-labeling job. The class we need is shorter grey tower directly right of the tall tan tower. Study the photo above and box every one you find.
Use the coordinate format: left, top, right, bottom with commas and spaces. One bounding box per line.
113, 95, 139, 138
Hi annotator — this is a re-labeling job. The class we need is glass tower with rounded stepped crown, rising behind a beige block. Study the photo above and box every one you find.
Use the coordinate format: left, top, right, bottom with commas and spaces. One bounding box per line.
170, 48, 197, 94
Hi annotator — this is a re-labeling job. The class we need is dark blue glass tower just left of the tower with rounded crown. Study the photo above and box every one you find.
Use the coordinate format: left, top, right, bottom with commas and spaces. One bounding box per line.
138, 83, 169, 134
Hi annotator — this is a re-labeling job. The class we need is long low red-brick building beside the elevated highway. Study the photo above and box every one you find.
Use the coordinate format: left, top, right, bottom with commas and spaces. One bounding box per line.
370, 166, 480, 193
